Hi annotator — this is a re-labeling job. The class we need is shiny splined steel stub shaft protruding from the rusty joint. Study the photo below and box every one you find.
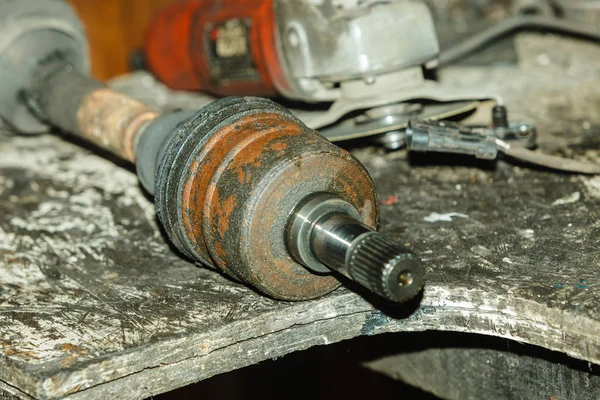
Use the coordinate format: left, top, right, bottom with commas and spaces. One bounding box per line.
288, 193, 423, 302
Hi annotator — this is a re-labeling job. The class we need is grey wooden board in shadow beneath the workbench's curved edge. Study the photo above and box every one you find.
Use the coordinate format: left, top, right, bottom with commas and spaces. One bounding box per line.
367, 345, 600, 400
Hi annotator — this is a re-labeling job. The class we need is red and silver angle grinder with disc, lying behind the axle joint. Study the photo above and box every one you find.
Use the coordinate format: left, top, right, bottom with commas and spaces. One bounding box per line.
145, 0, 497, 144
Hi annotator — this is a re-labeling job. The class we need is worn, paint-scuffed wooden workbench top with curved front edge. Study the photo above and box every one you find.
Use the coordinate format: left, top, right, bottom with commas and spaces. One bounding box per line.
0, 35, 600, 399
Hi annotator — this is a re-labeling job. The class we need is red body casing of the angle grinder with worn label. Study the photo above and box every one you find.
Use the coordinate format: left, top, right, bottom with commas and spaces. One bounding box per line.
145, 0, 287, 97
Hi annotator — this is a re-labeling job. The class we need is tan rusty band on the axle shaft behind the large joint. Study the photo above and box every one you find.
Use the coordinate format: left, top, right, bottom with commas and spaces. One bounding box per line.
77, 89, 158, 162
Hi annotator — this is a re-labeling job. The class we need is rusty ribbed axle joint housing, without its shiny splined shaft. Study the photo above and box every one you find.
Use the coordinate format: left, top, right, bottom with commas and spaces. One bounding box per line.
156, 98, 377, 300
